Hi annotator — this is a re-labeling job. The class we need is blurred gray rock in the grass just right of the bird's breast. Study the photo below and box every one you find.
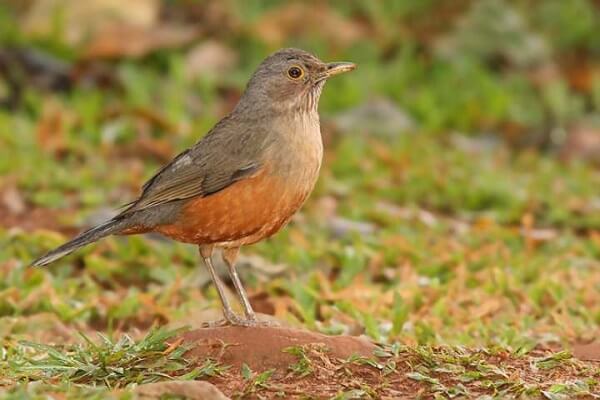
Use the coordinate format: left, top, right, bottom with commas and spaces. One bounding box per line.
329, 98, 415, 136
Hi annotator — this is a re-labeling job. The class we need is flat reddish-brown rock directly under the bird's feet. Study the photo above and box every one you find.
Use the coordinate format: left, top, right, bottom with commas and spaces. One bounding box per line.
183, 326, 376, 371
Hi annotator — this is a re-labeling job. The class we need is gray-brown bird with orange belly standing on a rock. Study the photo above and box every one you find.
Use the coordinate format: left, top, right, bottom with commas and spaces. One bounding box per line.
31, 48, 356, 327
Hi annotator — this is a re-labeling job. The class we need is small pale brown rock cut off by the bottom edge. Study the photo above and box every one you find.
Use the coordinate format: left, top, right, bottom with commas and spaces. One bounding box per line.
133, 381, 229, 400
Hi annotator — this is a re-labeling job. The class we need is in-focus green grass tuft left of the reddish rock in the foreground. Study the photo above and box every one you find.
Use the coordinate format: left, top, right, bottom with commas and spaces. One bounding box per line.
3, 329, 195, 388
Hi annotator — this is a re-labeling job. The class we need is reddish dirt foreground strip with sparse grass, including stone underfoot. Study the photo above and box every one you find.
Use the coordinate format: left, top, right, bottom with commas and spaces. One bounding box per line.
181, 326, 600, 399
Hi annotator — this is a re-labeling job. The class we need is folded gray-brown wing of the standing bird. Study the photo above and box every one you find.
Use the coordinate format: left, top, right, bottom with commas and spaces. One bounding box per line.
122, 118, 261, 214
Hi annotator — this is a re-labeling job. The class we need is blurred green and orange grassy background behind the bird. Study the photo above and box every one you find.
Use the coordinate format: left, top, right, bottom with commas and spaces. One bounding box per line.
0, 0, 600, 351
